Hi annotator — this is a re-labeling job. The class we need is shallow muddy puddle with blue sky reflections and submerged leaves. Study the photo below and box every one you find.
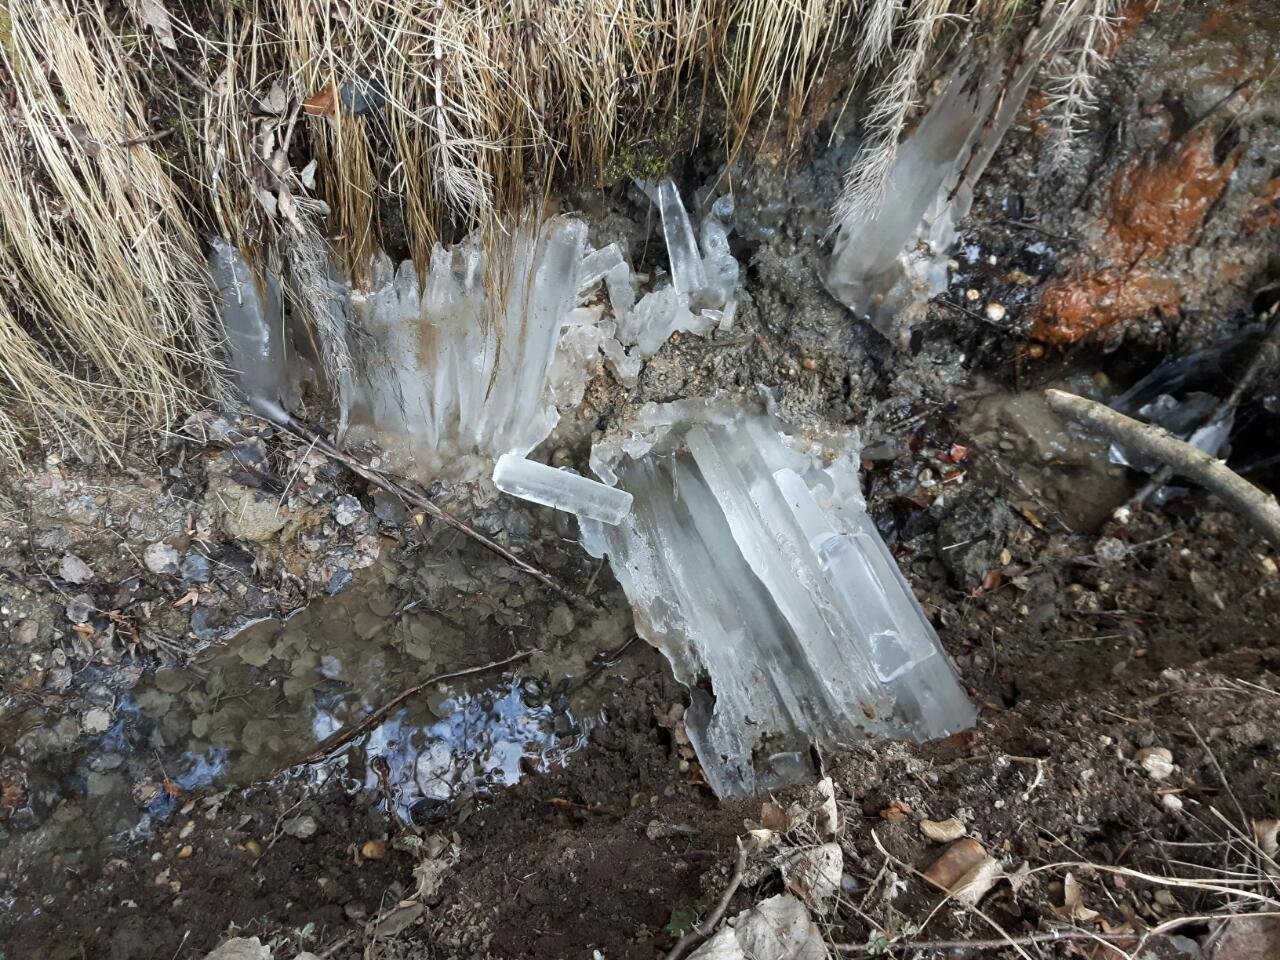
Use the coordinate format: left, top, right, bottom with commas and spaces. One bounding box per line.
0, 542, 627, 906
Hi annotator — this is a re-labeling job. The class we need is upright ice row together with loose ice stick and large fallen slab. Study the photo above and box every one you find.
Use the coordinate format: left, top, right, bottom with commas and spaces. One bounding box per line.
212, 180, 974, 795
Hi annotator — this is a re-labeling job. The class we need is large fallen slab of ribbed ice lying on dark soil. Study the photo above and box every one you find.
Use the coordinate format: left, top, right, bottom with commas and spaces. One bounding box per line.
581, 401, 975, 796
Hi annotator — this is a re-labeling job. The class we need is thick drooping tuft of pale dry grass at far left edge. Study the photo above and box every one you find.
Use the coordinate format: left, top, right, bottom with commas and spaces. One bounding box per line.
0, 0, 216, 465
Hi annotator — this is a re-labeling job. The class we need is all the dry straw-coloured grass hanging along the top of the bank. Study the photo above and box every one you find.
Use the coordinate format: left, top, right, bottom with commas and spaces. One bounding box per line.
0, 0, 1111, 460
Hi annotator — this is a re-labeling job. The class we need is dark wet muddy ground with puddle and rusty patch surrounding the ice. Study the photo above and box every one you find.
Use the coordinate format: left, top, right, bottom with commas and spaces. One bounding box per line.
0, 3, 1280, 959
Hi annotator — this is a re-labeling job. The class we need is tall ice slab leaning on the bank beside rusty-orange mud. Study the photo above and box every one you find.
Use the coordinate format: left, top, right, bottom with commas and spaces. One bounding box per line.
827, 42, 1046, 343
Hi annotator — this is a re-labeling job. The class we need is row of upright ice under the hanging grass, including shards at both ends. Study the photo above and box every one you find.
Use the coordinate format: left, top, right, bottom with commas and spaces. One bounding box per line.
217, 180, 739, 480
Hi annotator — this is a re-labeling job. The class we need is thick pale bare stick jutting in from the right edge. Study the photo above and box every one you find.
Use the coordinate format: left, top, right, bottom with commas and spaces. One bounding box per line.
1044, 390, 1280, 549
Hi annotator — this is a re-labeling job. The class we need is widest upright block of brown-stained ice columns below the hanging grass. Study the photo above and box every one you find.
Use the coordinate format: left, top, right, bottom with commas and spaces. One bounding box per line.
352, 218, 591, 479
